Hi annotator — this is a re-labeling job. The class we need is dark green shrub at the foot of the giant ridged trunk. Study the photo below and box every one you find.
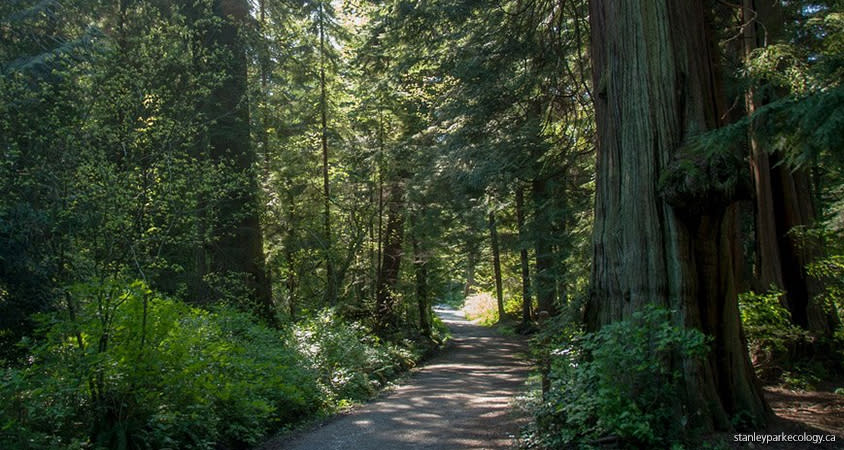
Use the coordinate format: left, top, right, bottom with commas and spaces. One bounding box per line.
535, 307, 707, 448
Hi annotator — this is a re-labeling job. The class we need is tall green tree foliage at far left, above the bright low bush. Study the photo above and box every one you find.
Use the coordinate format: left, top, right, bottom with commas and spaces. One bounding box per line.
0, 0, 274, 348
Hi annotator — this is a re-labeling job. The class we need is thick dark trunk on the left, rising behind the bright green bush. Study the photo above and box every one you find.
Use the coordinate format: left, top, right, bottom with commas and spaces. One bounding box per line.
203, 0, 275, 323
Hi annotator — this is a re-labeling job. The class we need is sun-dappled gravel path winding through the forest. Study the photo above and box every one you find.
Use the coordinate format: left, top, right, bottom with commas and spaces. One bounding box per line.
260, 308, 530, 450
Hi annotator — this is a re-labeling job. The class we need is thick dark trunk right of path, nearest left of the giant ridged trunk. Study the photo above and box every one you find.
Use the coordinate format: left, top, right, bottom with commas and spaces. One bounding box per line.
531, 176, 557, 316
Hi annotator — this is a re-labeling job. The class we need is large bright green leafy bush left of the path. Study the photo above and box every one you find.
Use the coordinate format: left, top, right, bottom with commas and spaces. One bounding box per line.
0, 280, 320, 449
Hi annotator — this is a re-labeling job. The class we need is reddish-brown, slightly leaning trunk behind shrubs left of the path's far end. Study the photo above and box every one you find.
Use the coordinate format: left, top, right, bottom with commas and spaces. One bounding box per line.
375, 180, 404, 329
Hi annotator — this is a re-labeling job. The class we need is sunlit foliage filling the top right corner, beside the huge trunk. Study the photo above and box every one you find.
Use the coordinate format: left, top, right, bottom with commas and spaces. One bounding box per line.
696, 1, 844, 168
